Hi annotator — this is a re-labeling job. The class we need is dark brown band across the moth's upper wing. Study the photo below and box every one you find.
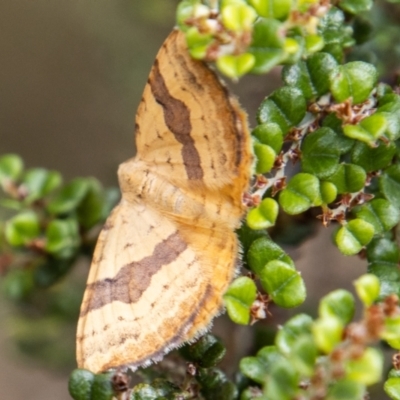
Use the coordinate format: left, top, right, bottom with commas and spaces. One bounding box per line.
149, 60, 204, 180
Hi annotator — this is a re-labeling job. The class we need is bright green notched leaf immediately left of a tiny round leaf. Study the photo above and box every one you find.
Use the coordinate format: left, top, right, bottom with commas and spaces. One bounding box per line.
279, 173, 322, 215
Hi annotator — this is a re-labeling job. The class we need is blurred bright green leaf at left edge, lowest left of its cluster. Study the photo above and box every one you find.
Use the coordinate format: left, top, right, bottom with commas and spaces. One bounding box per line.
4, 211, 40, 246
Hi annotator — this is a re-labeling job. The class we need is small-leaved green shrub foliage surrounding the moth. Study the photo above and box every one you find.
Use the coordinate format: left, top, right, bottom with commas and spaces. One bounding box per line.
0, 0, 400, 400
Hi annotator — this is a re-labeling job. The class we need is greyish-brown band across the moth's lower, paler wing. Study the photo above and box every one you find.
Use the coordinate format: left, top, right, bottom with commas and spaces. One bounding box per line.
80, 232, 187, 317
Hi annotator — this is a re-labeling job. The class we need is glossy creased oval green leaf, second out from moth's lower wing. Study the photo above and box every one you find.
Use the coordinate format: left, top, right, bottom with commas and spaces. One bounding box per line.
260, 260, 306, 308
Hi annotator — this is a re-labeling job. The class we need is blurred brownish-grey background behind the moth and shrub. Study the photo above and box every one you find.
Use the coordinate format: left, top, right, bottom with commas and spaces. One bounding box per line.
0, 0, 400, 400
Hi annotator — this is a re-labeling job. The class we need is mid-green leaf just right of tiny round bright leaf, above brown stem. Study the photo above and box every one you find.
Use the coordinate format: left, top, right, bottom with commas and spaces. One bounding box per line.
328, 164, 367, 194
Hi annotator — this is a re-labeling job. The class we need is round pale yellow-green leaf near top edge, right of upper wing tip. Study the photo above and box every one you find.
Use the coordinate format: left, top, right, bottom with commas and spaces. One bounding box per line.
221, 4, 257, 32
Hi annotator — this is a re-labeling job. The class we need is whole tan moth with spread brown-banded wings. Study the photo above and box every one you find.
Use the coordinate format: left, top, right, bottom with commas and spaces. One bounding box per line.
76, 30, 252, 373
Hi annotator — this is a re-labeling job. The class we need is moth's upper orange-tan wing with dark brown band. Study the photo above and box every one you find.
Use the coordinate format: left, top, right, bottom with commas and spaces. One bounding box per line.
136, 30, 251, 193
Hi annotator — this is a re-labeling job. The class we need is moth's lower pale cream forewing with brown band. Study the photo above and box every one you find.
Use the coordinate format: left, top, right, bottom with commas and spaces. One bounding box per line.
77, 200, 209, 373
